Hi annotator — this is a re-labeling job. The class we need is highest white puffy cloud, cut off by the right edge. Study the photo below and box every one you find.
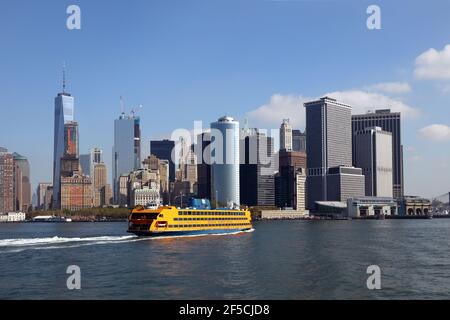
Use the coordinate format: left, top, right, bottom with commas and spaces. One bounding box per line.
414, 44, 450, 80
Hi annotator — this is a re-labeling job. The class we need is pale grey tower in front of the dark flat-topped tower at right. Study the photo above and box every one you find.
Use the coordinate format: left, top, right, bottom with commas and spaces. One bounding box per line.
353, 127, 393, 198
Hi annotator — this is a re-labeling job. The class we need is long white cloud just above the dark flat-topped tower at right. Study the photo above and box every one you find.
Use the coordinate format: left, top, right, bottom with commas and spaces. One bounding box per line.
327, 90, 419, 118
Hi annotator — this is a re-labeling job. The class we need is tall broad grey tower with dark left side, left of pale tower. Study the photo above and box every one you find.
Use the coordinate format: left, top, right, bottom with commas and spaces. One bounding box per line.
304, 97, 364, 209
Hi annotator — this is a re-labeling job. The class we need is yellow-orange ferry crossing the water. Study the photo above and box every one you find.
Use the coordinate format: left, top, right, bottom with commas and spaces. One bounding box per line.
128, 206, 252, 236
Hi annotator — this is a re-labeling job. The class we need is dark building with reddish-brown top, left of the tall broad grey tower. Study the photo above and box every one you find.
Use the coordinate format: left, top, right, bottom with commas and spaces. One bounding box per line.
275, 150, 306, 208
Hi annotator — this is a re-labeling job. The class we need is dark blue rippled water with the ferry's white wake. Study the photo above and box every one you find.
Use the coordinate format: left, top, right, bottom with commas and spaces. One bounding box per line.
0, 219, 450, 299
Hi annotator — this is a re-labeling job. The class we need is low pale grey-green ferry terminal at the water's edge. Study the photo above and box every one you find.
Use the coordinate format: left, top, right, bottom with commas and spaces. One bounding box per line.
347, 197, 397, 218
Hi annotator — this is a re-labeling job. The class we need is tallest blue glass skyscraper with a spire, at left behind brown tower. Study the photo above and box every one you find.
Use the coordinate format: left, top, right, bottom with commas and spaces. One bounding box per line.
53, 79, 74, 209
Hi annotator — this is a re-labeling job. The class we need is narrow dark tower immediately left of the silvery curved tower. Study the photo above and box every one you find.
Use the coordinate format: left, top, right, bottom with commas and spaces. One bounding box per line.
194, 133, 211, 199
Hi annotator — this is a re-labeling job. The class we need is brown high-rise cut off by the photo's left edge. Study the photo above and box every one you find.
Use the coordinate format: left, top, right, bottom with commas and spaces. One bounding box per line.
0, 147, 14, 213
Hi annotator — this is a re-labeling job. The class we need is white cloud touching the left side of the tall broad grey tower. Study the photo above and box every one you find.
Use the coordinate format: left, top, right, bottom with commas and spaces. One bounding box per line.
247, 94, 312, 129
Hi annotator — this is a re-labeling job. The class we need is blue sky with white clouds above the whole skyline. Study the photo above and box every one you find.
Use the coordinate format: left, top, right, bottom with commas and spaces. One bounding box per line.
0, 0, 450, 196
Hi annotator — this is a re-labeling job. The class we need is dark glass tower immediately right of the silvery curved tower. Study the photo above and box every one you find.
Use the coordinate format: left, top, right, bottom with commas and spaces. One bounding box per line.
239, 129, 276, 206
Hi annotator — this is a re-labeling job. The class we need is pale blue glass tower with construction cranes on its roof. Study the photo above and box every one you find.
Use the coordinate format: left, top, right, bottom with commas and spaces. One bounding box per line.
112, 113, 141, 205
